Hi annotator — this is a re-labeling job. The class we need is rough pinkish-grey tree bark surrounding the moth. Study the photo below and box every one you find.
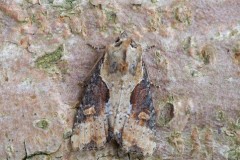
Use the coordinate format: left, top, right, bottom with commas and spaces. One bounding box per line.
0, 0, 240, 160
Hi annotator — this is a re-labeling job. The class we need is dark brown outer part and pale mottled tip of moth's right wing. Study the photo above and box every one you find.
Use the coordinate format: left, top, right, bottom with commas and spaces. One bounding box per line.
122, 65, 156, 155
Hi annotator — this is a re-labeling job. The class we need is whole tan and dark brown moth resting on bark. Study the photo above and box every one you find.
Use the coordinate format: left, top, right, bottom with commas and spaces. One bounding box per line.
71, 32, 156, 156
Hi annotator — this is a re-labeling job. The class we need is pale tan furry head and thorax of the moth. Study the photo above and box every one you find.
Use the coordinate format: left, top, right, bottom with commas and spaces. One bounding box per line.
107, 32, 142, 75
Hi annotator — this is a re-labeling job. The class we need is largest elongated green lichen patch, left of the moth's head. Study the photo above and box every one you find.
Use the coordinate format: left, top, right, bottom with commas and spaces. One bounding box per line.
35, 45, 63, 69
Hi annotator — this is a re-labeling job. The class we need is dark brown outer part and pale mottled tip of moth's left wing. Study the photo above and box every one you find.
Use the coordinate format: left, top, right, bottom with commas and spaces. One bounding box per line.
71, 59, 109, 150
